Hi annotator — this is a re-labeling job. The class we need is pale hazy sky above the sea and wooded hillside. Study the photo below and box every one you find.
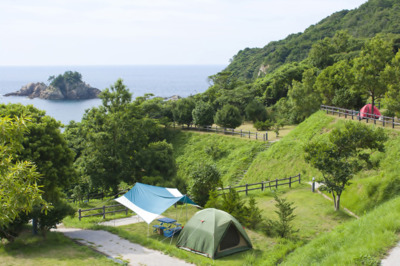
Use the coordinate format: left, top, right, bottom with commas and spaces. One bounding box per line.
0, 0, 366, 66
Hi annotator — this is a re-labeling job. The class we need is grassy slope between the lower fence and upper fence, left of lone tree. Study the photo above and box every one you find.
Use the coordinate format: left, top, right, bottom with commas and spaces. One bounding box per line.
242, 112, 335, 184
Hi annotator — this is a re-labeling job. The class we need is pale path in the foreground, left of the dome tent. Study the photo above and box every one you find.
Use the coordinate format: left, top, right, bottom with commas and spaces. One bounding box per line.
54, 225, 191, 266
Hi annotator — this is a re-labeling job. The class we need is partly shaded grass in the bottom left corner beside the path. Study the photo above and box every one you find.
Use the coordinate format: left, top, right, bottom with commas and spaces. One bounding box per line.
0, 231, 120, 266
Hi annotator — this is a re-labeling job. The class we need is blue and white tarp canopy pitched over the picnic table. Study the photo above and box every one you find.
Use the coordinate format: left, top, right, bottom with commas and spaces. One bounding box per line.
116, 183, 196, 224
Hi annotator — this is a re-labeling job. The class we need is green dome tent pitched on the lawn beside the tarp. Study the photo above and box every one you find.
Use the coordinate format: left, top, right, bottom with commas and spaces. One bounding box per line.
176, 208, 252, 259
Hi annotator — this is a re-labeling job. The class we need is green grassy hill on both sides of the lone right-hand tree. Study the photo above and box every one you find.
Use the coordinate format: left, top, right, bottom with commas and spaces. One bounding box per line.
241, 111, 400, 215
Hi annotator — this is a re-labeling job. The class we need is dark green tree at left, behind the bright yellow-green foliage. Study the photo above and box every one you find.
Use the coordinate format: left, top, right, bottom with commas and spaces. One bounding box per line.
0, 104, 76, 237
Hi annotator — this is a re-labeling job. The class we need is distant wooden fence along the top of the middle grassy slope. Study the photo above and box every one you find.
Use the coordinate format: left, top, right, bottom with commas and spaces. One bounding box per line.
174, 125, 268, 141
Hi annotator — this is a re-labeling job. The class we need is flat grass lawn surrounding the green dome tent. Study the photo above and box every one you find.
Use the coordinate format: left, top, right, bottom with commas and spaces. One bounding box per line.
64, 185, 353, 265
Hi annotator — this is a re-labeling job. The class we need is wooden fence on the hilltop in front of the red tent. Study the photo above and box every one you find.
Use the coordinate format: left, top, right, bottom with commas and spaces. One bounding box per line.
321, 105, 400, 128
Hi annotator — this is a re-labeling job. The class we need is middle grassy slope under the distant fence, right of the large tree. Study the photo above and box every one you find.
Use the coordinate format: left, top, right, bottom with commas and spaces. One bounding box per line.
172, 132, 265, 185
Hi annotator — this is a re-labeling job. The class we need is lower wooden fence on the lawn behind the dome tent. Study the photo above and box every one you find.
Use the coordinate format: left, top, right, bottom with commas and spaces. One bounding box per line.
218, 174, 301, 196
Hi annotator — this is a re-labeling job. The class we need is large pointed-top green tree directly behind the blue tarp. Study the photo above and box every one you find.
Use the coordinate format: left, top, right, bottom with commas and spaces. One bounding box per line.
66, 80, 169, 192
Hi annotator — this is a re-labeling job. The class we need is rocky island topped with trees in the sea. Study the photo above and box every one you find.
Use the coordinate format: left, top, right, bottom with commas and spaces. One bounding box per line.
4, 71, 101, 100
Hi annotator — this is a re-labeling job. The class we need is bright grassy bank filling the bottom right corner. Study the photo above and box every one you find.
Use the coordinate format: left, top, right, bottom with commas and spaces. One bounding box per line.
284, 194, 400, 265
